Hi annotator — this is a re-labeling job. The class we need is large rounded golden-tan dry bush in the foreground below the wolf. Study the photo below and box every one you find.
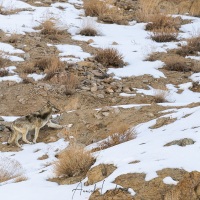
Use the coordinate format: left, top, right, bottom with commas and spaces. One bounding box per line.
54, 145, 95, 177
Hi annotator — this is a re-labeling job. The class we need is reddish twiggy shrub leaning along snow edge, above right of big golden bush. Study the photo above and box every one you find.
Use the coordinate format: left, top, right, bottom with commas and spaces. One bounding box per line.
100, 124, 136, 149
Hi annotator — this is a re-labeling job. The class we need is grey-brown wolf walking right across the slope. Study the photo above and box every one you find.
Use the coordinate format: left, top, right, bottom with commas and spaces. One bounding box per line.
7, 101, 63, 148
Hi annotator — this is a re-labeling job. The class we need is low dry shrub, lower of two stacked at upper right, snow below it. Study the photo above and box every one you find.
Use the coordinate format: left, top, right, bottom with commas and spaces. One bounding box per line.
150, 28, 178, 42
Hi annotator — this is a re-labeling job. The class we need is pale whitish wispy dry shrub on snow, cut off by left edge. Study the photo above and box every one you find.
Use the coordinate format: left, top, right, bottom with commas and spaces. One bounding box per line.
0, 158, 23, 183
